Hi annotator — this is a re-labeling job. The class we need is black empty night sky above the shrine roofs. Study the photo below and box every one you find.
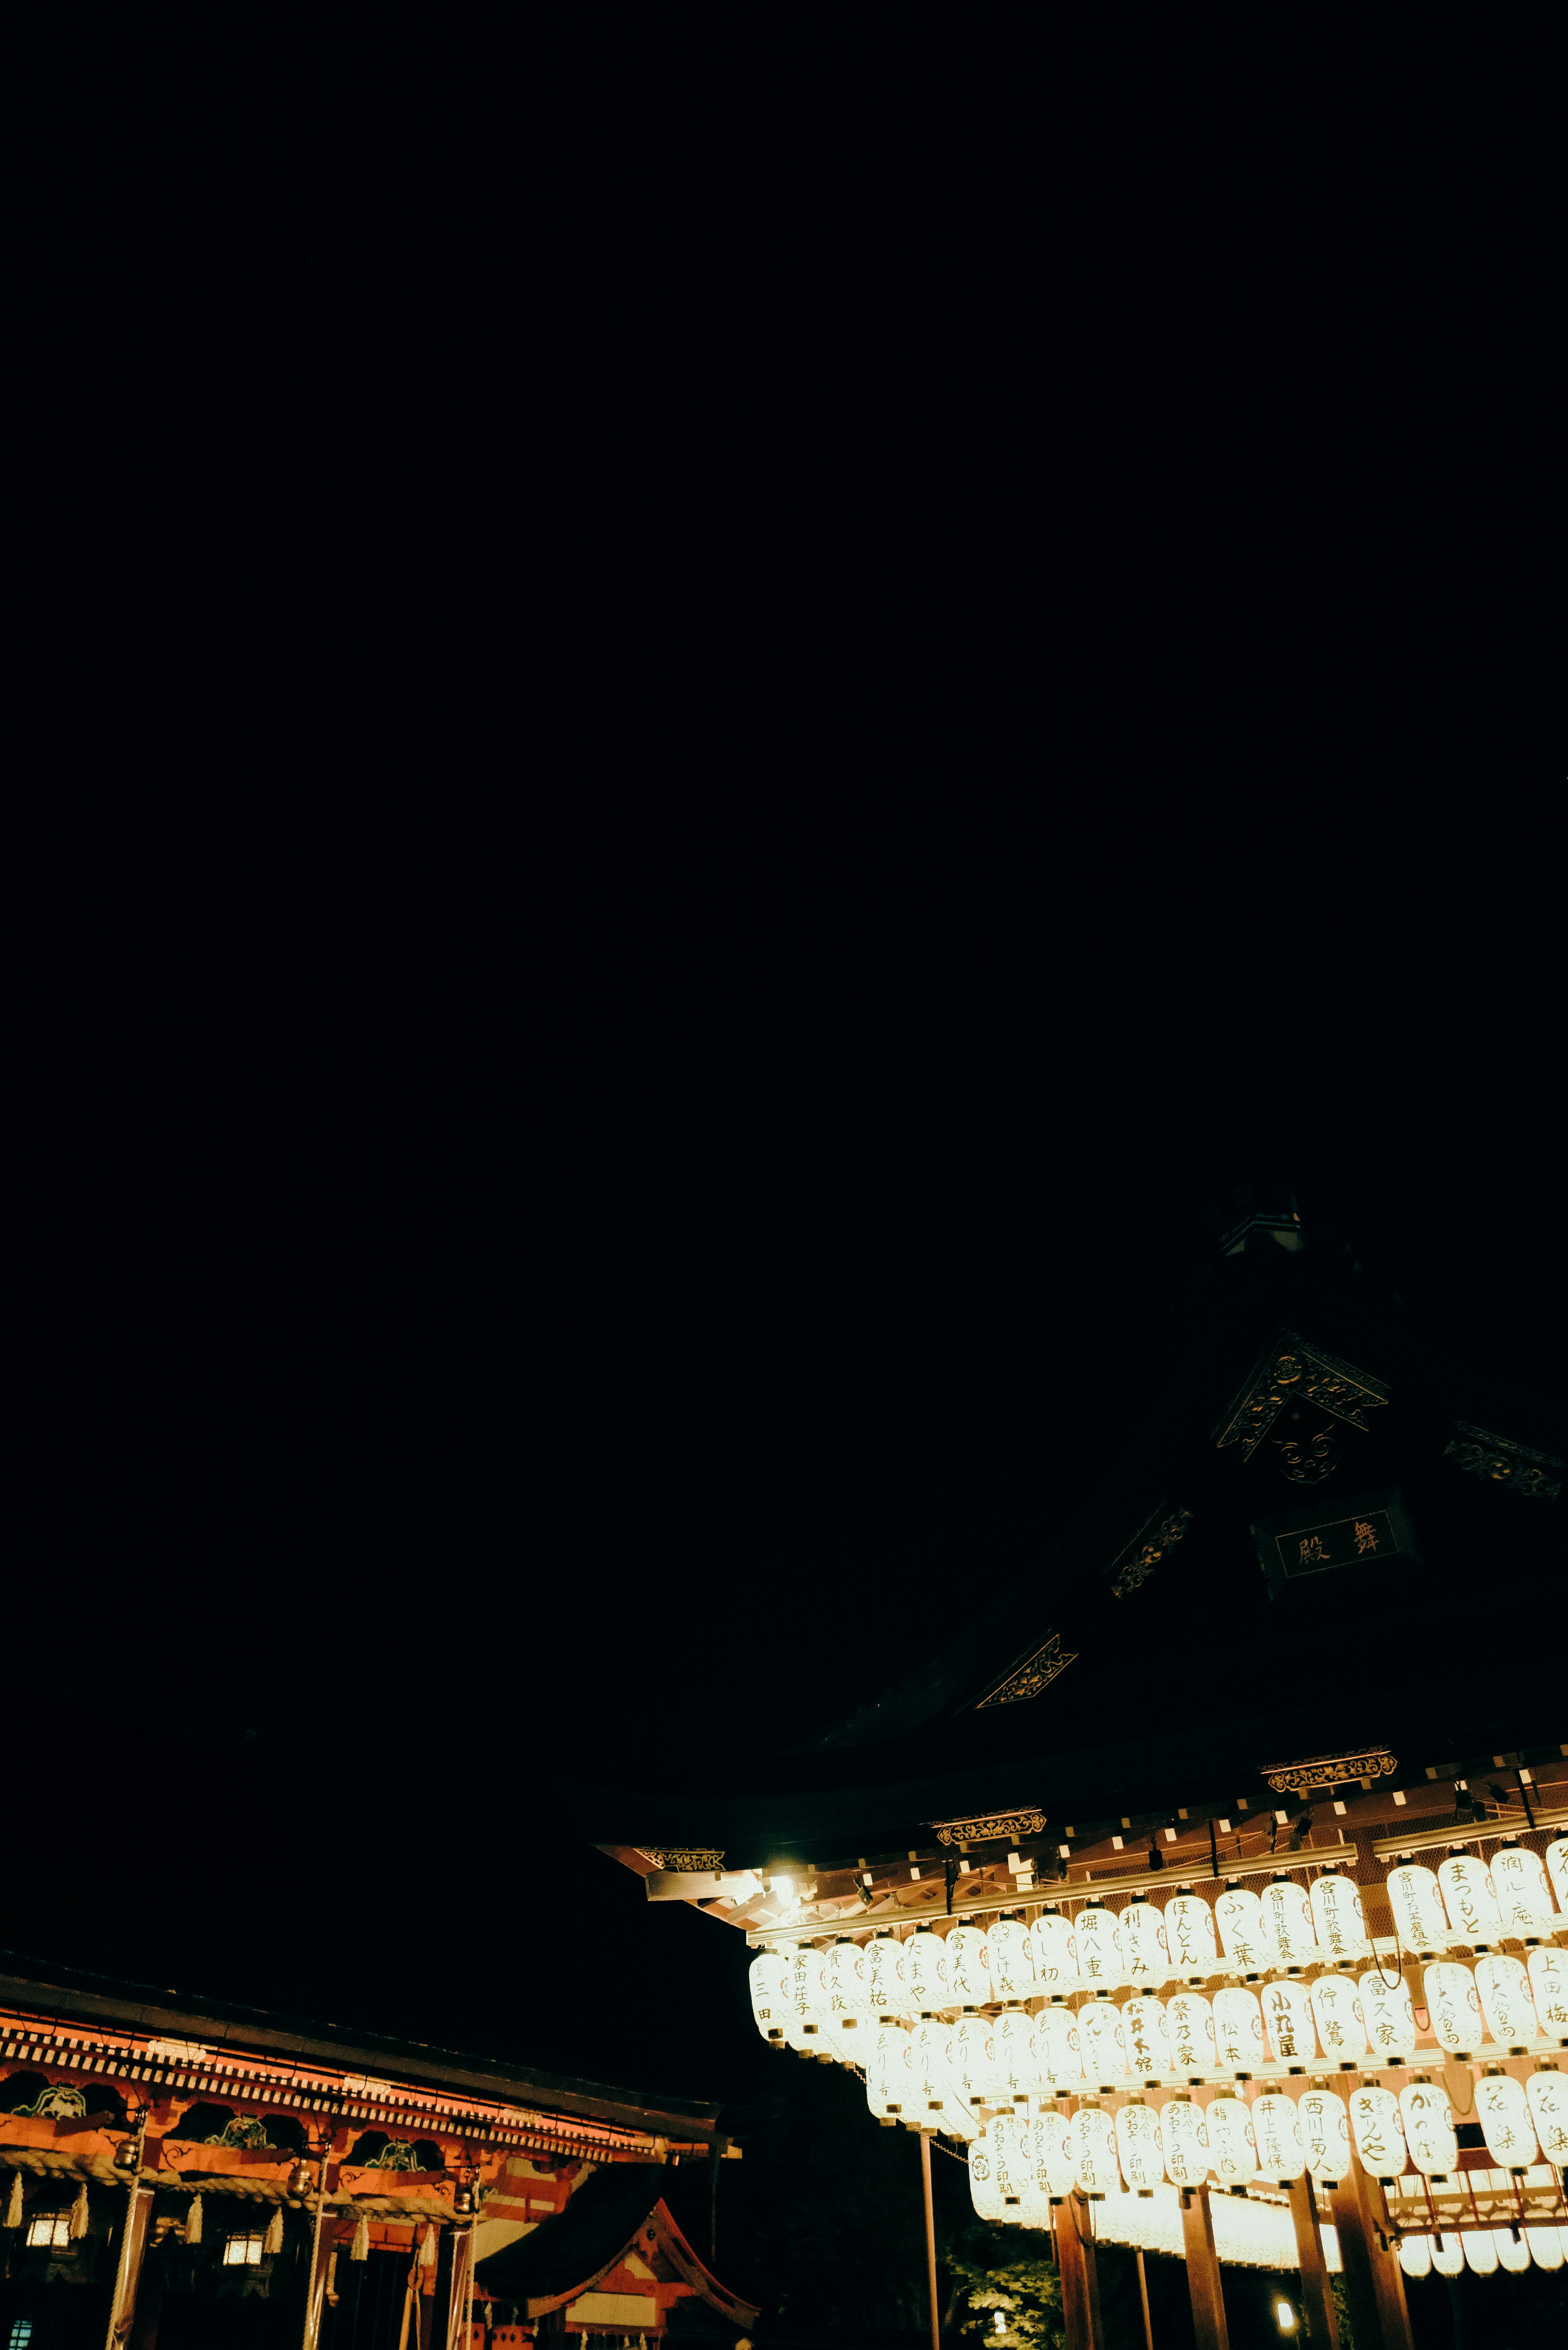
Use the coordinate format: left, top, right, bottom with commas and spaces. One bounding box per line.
0, 13, 1563, 2162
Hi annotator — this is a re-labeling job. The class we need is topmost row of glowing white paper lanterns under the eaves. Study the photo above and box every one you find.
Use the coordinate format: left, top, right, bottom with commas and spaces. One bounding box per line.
747, 1838, 1568, 2016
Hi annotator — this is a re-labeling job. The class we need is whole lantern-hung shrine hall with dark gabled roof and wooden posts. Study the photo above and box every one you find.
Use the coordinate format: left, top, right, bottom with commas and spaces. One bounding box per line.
576, 1199, 1568, 2350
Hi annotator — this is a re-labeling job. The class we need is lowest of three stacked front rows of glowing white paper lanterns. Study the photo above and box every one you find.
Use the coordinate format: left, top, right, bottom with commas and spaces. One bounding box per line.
969, 2066, 1568, 2218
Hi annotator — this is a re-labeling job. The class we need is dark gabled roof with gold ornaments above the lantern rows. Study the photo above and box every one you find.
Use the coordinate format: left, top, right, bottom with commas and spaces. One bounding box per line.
576, 1220, 1568, 1871
